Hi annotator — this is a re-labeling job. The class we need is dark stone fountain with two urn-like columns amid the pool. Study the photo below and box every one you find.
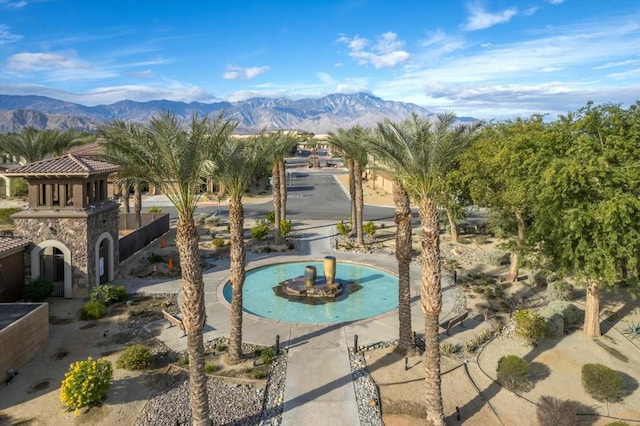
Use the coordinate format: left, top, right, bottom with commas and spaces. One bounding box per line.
274, 256, 361, 304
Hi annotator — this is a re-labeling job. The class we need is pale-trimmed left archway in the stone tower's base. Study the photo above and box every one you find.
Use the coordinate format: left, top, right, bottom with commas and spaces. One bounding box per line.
31, 240, 72, 298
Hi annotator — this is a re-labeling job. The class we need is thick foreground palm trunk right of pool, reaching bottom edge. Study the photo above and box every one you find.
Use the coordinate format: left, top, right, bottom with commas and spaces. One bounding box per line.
420, 198, 445, 426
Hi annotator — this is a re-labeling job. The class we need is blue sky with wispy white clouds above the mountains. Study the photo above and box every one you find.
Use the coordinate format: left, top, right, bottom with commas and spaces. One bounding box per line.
0, 0, 640, 119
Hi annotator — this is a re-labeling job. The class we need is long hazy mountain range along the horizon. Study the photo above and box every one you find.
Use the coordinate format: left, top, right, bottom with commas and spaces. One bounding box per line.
0, 93, 476, 134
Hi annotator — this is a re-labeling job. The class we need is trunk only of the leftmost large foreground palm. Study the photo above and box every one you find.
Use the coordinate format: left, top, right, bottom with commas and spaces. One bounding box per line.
176, 217, 212, 425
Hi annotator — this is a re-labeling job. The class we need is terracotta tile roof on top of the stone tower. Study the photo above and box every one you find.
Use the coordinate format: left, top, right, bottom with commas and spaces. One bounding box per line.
7, 154, 120, 176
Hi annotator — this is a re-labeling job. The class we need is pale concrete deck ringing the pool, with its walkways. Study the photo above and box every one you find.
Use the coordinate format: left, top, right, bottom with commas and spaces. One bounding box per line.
114, 221, 455, 425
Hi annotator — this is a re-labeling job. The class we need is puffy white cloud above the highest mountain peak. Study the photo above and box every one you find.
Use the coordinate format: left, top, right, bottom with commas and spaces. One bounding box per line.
337, 32, 409, 68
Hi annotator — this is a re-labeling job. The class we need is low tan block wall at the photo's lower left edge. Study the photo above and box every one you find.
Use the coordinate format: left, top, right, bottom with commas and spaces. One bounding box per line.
0, 303, 49, 378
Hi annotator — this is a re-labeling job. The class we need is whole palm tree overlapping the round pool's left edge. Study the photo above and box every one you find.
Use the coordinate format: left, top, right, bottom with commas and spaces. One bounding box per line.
214, 132, 270, 364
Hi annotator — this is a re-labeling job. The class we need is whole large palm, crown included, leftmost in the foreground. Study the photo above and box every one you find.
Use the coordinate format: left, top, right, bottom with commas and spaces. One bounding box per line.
105, 112, 237, 425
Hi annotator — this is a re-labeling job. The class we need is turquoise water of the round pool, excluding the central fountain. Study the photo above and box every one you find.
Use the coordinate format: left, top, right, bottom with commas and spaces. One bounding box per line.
223, 262, 398, 324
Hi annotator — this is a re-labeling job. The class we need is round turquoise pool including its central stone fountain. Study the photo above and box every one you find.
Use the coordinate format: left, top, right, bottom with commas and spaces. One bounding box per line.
219, 256, 398, 324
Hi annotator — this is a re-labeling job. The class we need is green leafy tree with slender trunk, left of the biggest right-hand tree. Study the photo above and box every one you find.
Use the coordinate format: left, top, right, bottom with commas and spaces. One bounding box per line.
461, 115, 549, 281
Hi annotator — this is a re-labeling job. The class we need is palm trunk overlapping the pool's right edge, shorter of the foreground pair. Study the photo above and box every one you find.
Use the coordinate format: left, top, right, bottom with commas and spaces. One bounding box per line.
393, 183, 412, 354
